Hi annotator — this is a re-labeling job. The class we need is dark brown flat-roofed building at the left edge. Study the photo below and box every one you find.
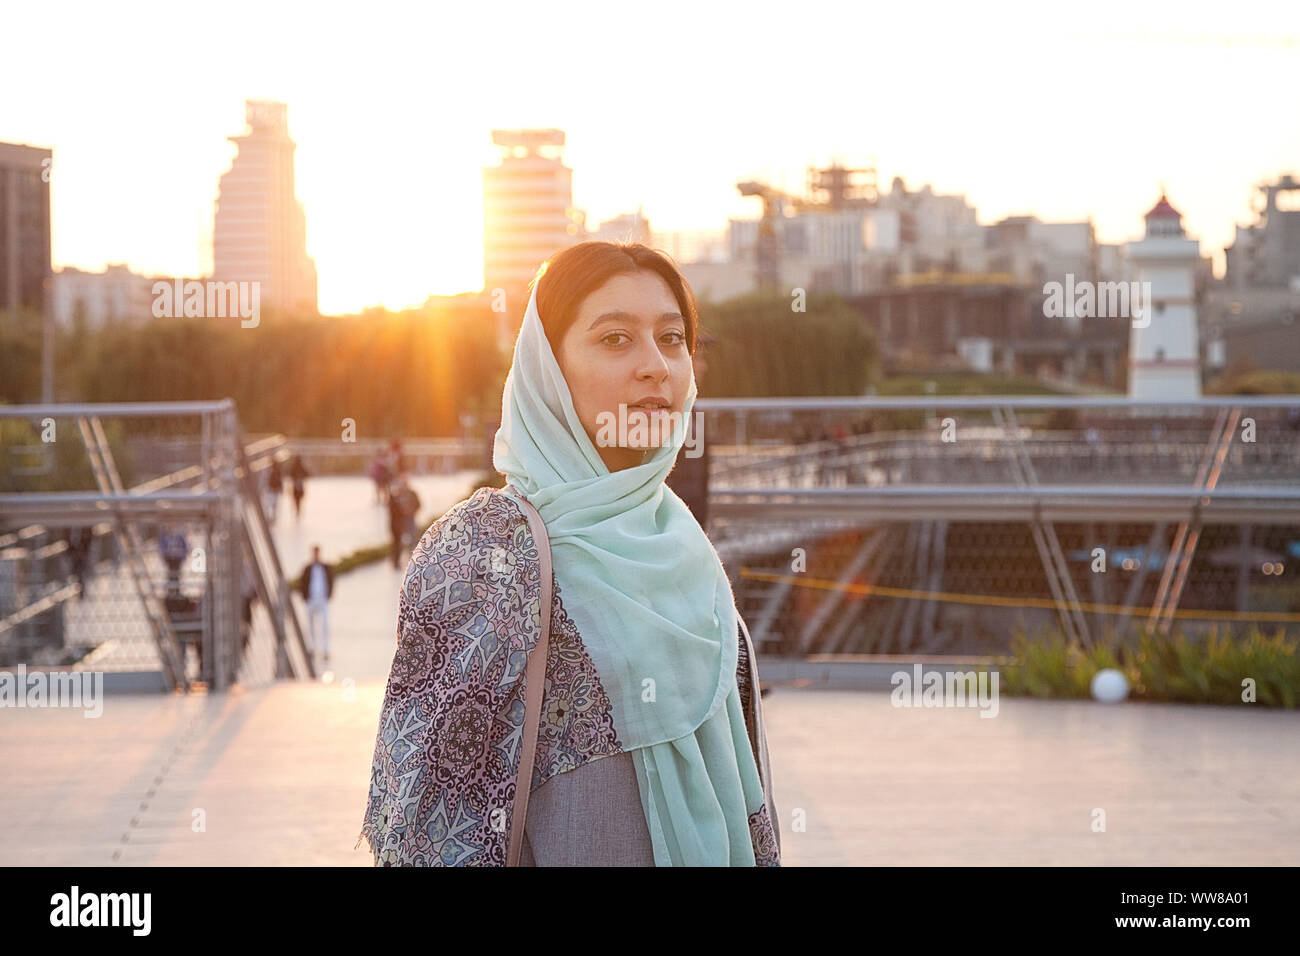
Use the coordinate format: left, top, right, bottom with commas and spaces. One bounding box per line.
0, 143, 53, 312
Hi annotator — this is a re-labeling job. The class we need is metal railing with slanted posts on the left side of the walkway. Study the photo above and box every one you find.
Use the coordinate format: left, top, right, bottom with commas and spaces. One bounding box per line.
0, 401, 313, 689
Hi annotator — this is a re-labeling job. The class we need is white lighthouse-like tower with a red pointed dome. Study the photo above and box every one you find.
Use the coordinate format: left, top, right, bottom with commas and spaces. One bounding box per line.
1128, 190, 1201, 402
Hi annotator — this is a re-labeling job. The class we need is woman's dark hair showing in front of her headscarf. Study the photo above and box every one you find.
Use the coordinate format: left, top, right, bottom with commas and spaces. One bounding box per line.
528, 239, 699, 355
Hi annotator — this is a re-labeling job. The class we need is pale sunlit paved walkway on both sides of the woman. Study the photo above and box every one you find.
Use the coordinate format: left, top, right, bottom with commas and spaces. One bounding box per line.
0, 470, 1300, 866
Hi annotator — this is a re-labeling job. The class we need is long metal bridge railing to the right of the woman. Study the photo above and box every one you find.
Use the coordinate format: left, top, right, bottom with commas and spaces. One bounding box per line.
697, 395, 1300, 654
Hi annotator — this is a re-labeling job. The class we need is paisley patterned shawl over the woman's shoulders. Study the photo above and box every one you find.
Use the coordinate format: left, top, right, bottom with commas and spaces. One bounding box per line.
358, 488, 780, 866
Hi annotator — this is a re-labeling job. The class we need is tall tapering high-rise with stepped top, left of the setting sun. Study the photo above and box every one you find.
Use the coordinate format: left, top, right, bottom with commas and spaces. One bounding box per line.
212, 100, 316, 313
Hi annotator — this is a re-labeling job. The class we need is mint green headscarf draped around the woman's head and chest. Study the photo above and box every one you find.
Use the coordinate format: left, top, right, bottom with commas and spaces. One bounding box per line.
493, 278, 763, 866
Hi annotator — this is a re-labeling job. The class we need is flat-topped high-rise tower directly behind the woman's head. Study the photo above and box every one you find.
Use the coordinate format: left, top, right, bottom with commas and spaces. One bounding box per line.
484, 130, 586, 293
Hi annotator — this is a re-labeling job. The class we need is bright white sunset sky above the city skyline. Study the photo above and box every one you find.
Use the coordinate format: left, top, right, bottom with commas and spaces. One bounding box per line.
0, 0, 1300, 312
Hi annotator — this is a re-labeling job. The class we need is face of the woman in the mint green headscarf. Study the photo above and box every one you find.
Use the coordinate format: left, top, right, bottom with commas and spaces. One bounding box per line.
555, 269, 693, 472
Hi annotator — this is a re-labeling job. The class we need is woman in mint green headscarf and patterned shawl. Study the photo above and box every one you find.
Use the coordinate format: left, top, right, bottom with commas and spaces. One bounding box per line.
358, 242, 780, 866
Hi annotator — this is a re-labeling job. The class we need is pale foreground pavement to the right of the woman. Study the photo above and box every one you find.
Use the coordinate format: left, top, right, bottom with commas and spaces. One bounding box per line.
764, 687, 1300, 866
